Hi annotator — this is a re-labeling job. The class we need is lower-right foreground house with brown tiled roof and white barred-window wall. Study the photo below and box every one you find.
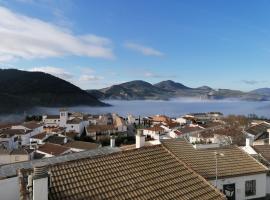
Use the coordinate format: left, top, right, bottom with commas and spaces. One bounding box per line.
162, 139, 268, 200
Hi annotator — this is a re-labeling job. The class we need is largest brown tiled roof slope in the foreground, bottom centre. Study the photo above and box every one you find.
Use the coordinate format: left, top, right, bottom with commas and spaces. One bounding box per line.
49, 145, 225, 200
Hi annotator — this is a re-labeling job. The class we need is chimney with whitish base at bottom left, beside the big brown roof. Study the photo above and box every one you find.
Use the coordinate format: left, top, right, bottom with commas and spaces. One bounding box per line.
33, 163, 48, 200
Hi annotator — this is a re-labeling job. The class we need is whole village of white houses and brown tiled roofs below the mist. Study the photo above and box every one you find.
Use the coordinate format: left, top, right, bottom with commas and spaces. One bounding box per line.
0, 109, 270, 200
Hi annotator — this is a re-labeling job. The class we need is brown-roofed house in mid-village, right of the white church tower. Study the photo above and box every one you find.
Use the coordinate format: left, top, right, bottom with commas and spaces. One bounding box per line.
86, 125, 117, 140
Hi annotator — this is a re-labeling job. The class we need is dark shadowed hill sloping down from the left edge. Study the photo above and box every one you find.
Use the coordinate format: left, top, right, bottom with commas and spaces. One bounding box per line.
0, 69, 106, 113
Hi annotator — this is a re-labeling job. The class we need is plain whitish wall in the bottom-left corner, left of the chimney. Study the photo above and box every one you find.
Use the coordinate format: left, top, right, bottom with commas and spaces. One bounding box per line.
0, 177, 20, 200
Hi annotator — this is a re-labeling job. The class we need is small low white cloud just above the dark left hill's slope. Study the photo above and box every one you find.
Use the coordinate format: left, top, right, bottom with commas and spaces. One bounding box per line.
29, 66, 73, 79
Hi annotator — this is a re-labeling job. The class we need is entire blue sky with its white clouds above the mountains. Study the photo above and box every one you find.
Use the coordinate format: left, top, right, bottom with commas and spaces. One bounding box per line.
0, 0, 270, 91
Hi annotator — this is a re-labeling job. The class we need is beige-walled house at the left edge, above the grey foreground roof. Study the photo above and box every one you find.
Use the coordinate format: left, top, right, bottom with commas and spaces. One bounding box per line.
0, 148, 31, 165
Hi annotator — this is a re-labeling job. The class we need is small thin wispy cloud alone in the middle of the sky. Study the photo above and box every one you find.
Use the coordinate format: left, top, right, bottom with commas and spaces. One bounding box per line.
124, 42, 164, 56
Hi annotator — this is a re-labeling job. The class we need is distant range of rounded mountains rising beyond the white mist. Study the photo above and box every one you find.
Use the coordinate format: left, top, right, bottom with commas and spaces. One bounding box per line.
88, 80, 270, 101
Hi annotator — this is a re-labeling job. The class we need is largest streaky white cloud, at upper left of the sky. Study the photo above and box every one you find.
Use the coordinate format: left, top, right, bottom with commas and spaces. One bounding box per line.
0, 7, 114, 61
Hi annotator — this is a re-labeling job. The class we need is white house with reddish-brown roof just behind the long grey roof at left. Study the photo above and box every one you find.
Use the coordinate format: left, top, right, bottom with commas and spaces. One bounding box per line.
36, 143, 72, 157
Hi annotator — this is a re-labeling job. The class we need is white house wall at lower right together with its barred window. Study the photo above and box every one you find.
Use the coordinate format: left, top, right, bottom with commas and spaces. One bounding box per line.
209, 173, 267, 200
